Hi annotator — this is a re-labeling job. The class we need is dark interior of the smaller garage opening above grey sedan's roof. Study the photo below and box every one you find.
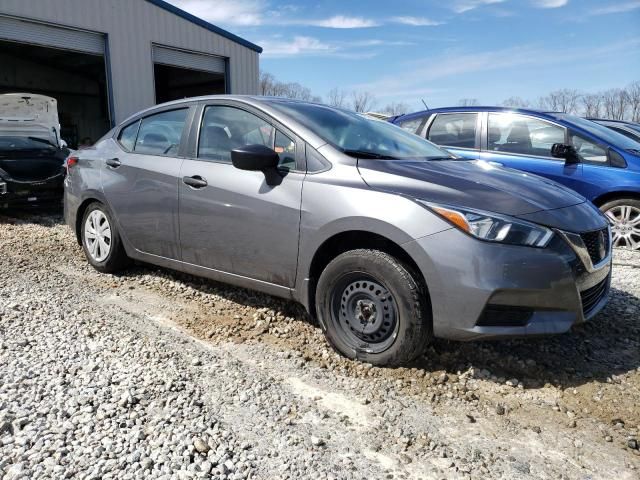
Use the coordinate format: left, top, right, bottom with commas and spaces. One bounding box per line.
153, 63, 225, 103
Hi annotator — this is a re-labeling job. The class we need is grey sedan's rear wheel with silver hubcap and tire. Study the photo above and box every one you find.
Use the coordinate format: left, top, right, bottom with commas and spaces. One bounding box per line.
81, 202, 129, 273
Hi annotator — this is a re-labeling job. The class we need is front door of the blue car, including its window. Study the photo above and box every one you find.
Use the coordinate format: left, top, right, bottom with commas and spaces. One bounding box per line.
480, 112, 582, 188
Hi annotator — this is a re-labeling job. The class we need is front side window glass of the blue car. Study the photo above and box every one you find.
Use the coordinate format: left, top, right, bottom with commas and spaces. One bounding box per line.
487, 113, 565, 157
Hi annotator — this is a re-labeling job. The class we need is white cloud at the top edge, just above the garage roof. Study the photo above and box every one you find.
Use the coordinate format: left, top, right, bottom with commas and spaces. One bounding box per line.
169, 0, 266, 26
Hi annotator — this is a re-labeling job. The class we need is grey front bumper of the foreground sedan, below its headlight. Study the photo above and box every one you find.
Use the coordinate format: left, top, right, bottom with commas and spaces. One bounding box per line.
403, 229, 611, 340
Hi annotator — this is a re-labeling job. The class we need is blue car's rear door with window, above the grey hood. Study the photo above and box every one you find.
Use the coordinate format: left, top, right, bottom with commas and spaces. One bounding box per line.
426, 112, 480, 159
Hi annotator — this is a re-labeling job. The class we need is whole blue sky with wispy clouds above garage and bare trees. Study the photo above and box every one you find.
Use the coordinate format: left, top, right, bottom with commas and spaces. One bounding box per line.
170, 0, 640, 109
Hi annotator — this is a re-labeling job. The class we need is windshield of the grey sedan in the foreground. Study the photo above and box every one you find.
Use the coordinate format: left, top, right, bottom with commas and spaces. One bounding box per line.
270, 101, 455, 160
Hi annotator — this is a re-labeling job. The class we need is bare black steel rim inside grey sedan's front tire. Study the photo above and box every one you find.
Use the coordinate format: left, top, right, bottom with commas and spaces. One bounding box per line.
331, 273, 398, 353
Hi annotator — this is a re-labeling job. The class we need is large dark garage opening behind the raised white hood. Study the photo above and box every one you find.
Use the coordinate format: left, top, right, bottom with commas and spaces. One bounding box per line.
0, 40, 111, 148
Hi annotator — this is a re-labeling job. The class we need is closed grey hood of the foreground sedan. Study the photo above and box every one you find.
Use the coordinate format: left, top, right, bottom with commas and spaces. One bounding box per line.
358, 159, 585, 216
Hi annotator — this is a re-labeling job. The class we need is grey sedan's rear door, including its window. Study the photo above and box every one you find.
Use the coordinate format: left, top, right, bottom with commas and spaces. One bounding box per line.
102, 106, 195, 260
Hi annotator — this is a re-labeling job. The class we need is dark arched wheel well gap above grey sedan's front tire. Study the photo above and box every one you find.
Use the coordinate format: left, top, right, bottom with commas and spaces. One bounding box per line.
308, 230, 428, 317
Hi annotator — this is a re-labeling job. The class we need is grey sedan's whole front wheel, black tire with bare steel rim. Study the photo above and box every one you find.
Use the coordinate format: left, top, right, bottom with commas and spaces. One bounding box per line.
316, 249, 433, 366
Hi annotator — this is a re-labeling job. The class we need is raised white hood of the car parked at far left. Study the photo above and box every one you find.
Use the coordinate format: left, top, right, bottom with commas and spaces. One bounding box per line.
0, 93, 60, 145
